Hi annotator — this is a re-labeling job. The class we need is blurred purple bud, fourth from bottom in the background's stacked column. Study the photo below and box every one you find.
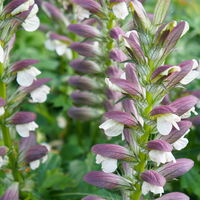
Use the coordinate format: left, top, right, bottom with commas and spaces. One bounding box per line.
70, 58, 101, 74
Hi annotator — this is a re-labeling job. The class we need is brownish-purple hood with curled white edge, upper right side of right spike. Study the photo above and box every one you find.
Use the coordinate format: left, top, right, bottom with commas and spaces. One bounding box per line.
151, 65, 181, 81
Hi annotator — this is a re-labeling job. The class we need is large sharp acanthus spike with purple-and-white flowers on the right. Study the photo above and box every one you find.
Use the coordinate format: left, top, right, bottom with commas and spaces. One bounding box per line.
84, 0, 199, 200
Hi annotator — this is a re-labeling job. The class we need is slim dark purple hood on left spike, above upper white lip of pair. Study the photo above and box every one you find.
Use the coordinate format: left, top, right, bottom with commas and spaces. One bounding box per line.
11, 59, 39, 72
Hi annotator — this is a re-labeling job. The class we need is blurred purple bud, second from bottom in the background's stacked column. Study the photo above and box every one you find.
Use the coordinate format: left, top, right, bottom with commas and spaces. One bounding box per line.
70, 90, 102, 105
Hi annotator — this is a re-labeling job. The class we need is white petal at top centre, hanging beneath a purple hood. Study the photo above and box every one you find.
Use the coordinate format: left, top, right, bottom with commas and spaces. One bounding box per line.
112, 2, 129, 19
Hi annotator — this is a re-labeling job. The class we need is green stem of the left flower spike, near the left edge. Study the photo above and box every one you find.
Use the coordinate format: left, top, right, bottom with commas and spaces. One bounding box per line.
0, 64, 20, 182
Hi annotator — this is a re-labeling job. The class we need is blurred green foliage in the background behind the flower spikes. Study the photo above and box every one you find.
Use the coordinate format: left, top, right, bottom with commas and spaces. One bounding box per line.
4, 0, 200, 200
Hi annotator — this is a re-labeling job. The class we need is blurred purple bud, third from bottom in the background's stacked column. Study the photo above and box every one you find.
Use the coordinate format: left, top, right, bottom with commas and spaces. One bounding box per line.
68, 76, 99, 90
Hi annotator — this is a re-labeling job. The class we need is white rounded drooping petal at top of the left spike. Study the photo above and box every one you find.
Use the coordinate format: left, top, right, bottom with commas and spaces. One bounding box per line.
22, 4, 40, 32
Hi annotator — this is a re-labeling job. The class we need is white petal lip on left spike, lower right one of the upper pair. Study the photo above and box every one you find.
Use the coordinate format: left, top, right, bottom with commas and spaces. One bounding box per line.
30, 85, 50, 103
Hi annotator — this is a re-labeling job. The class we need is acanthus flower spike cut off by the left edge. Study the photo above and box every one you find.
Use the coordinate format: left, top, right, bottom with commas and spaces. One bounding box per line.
0, 0, 50, 197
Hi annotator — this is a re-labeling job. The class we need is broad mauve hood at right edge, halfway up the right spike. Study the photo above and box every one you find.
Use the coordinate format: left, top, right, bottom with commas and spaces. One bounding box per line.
169, 95, 198, 118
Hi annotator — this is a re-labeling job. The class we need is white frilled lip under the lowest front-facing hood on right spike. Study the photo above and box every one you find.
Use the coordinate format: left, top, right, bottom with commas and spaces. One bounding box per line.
142, 181, 164, 195
